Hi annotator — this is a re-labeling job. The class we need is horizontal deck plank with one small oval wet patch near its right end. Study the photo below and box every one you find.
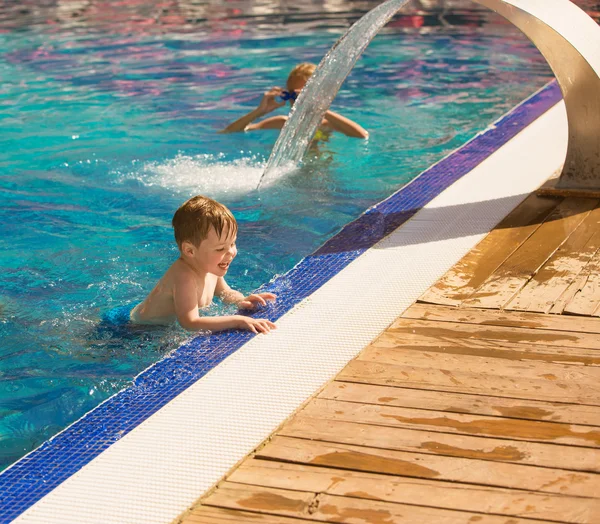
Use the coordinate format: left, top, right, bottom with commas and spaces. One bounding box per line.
318, 380, 600, 427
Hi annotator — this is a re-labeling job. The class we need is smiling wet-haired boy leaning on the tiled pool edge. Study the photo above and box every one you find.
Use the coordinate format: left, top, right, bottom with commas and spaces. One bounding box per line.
130, 195, 276, 333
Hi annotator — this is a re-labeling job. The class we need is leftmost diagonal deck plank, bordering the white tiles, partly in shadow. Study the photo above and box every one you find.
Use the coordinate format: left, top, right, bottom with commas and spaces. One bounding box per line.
419, 195, 562, 306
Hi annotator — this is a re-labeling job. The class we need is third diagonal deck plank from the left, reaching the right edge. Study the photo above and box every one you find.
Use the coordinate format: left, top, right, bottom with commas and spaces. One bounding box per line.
505, 208, 600, 314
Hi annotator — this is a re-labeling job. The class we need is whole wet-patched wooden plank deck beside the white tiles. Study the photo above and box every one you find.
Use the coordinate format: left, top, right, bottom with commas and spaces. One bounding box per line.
178, 195, 600, 524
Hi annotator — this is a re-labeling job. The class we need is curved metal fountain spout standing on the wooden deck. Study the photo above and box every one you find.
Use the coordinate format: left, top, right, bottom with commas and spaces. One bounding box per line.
473, 0, 600, 192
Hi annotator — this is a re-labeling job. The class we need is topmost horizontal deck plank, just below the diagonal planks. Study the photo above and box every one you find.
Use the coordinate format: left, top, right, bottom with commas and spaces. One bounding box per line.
402, 304, 600, 334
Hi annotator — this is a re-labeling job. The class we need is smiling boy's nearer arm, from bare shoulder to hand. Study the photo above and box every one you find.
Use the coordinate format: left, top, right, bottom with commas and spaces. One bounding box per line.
173, 272, 276, 333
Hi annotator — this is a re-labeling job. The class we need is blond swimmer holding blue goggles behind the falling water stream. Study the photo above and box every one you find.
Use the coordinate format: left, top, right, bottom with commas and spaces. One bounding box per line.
221, 62, 369, 138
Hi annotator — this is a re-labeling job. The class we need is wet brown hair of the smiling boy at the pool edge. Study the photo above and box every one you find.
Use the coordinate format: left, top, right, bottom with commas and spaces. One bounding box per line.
172, 195, 237, 249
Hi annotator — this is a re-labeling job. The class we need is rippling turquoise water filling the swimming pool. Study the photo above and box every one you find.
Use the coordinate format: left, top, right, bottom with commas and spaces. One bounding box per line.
0, 1, 576, 468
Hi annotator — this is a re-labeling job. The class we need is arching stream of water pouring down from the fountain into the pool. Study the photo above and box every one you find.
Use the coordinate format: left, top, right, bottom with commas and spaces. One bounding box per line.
257, 0, 408, 188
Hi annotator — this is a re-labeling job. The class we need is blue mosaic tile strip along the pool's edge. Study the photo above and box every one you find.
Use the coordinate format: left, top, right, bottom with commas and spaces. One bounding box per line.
0, 83, 561, 523
